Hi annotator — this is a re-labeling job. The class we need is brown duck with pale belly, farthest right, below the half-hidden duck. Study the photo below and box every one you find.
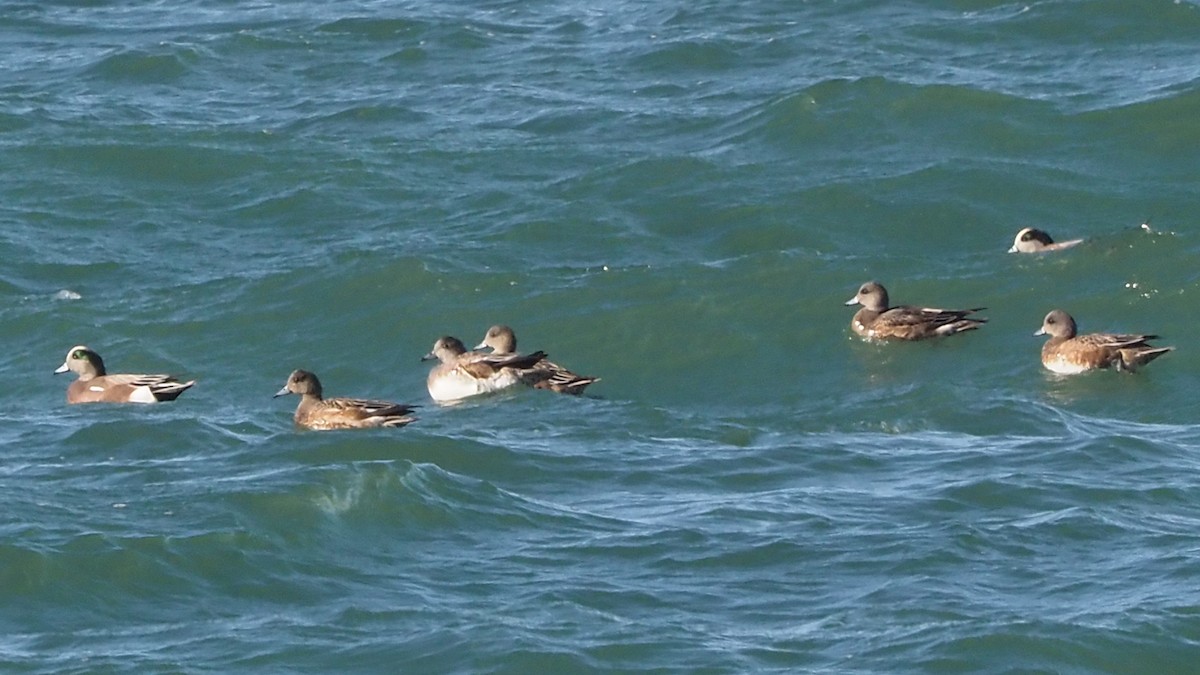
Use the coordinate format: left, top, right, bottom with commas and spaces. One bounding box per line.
1034, 310, 1174, 375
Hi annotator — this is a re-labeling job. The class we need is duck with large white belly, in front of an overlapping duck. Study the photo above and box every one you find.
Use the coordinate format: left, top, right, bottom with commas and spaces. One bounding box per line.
421, 335, 546, 404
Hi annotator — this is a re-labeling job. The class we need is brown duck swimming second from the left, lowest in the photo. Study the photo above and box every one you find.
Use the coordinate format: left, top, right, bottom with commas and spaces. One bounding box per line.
275, 370, 416, 431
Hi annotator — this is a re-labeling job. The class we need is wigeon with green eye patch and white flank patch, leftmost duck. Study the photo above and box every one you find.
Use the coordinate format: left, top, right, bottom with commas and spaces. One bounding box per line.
54, 345, 196, 404
